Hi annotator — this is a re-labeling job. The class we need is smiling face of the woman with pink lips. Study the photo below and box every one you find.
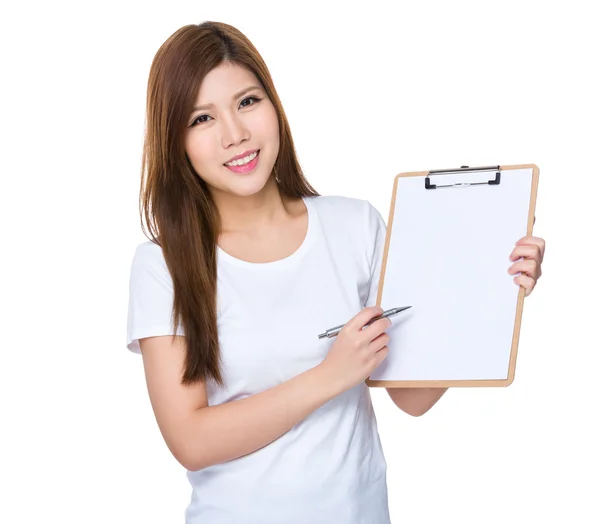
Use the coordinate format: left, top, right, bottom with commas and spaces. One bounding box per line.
185, 62, 279, 200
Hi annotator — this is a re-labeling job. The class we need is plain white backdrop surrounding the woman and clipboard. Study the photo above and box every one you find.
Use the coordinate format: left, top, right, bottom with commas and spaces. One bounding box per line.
0, 0, 600, 524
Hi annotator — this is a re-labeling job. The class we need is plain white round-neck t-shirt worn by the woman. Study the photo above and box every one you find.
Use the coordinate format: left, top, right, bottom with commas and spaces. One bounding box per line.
127, 196, 391, 524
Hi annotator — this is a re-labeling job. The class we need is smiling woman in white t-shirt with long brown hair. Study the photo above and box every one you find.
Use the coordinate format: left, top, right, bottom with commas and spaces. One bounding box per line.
127, 22, 543, 524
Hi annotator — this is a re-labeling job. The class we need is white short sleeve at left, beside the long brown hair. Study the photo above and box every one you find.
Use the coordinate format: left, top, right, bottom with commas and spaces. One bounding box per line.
127, 241, 184, 354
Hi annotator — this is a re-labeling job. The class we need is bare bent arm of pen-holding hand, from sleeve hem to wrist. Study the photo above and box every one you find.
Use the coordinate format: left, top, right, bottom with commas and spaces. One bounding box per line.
140, 335, 341, 471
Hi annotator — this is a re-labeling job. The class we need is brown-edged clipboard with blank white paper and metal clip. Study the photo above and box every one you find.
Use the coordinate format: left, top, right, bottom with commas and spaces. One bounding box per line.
366, 164, 539, 387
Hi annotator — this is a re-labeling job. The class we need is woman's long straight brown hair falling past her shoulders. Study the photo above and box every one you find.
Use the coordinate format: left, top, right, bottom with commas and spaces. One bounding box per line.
140, 21, 319, 385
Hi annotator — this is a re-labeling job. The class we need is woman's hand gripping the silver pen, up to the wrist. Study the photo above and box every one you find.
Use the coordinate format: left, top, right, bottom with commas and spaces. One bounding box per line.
319, 306, 392, 393
